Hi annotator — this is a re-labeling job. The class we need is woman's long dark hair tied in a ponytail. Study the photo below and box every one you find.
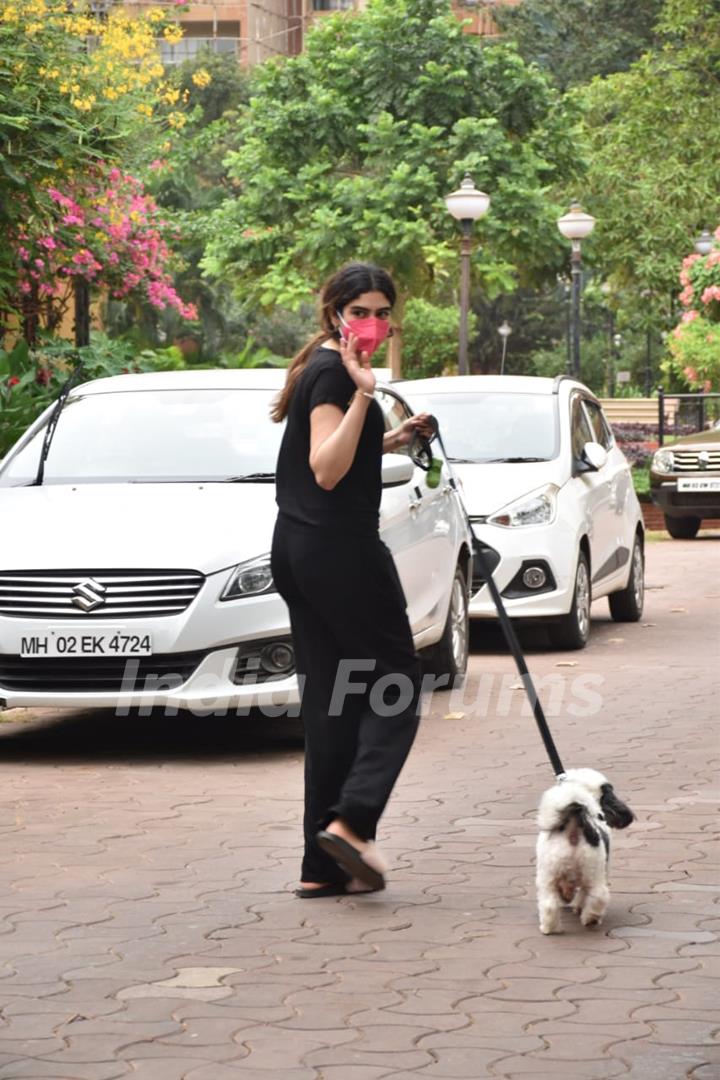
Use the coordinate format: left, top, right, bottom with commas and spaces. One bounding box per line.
270, 262, 396, 423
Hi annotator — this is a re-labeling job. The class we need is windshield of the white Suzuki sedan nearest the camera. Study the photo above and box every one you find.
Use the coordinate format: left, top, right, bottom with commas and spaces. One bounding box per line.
0, 388, 283, 487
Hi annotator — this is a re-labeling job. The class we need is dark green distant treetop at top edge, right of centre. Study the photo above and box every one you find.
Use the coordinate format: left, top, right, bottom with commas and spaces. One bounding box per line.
493, 0, 662, 89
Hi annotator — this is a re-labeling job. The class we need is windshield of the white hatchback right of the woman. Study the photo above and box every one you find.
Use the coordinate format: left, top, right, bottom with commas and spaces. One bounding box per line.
406, 388, 558, 463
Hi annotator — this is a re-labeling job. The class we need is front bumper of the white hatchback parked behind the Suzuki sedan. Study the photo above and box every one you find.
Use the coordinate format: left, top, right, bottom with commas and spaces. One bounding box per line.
470, 521, 578, 619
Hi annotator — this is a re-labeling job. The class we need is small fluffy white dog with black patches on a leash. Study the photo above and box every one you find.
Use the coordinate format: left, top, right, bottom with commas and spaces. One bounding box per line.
535, 769, 635, 934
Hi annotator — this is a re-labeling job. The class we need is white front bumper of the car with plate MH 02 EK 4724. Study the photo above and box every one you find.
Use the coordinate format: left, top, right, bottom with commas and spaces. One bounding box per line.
0, 571, 300, 715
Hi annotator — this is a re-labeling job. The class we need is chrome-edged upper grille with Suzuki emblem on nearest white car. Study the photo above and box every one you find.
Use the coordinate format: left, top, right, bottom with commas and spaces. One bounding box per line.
0, 570, 205, 619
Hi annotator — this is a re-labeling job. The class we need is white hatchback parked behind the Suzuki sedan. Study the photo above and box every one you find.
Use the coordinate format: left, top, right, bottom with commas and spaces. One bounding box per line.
394, 375, 644, 649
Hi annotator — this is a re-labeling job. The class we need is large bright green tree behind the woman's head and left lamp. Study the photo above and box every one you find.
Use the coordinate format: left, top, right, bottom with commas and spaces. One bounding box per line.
204, 0, 575, 369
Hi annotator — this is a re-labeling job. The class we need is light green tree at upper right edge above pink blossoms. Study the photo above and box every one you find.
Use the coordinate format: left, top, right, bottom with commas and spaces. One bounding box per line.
580, 0, 720, 317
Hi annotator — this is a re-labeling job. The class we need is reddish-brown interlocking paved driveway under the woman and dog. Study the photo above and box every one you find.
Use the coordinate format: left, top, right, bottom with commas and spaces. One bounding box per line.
0, 534, 720, 1080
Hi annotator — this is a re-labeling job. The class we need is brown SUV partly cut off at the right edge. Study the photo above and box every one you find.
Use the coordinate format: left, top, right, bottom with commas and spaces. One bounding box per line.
650, 420, 720, 540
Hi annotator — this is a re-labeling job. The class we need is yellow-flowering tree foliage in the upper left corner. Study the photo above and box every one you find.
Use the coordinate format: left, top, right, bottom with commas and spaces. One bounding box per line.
0, 0, 185, 309
